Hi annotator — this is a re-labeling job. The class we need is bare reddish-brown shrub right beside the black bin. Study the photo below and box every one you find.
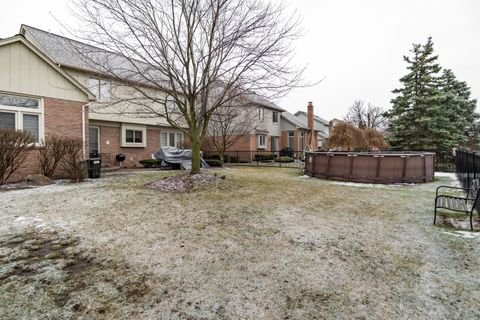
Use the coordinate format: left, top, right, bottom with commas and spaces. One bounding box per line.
60, 138, 88, 182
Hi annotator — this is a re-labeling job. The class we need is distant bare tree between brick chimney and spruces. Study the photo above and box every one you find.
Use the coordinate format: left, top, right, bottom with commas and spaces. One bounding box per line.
344, 100, 386, 131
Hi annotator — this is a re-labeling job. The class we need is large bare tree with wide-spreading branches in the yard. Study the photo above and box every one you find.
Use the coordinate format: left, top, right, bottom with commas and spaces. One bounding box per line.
72, 0, 303, 173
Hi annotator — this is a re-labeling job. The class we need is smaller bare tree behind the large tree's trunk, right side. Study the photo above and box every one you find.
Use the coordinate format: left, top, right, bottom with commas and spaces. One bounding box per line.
208, 103, 261, 161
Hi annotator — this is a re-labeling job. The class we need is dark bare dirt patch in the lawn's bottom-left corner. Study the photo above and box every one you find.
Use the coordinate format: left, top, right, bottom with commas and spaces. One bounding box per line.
0, 230, 161, 319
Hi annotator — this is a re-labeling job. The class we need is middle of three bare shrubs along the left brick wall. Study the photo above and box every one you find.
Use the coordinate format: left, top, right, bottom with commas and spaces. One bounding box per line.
38, 136, 66, 179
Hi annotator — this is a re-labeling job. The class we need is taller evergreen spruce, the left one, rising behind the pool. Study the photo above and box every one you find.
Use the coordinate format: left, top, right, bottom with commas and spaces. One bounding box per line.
386, 38, 469, 151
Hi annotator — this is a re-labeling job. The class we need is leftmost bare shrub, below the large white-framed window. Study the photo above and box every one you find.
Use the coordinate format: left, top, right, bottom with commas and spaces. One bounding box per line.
0, 128, 35, 185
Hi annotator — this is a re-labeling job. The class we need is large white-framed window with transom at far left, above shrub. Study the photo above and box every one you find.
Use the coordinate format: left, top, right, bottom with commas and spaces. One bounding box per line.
0, 95, 43, 143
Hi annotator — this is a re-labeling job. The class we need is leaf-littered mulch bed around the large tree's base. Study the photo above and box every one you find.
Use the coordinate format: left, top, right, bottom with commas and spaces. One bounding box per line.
146, 174, 225, 192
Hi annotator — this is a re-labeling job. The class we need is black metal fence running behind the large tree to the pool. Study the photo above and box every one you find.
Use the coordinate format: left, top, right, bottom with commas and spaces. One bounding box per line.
203, 150, 305, 168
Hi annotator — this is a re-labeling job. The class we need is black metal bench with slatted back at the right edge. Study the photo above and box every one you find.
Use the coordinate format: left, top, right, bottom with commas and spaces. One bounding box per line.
433, 179, 480, 231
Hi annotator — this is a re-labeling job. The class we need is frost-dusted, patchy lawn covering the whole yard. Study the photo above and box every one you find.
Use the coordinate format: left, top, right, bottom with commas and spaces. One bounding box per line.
0, 168, 480, 319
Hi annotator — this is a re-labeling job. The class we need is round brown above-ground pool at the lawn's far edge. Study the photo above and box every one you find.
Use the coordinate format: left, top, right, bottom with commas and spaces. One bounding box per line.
305, 152, 435, 183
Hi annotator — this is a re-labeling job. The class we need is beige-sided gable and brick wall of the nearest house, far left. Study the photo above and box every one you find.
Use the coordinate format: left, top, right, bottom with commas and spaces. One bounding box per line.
0, 35, 95, 182
